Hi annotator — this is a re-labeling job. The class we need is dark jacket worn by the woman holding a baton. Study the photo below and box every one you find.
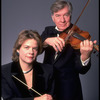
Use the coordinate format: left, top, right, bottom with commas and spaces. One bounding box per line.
1, 62, 54, 100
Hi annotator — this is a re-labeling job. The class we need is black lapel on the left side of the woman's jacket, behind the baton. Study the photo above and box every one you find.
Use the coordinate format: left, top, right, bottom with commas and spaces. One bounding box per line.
11, 62, 30, 97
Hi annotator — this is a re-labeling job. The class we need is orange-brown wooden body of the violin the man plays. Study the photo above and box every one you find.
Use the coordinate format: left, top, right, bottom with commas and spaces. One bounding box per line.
59, 26, 91, 49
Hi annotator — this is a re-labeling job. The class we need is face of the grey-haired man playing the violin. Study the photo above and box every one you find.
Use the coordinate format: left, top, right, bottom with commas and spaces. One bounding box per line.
52, 6, 71, 31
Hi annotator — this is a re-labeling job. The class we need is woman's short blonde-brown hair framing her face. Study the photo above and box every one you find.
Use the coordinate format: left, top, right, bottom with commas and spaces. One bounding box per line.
12, 30, 42, 62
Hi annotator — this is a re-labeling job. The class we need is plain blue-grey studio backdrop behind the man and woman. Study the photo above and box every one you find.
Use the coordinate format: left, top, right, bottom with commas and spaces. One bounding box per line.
1, 0, 99, 100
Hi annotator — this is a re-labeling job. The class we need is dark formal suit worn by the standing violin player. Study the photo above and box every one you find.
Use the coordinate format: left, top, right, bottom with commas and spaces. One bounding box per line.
41, 26, 91, 100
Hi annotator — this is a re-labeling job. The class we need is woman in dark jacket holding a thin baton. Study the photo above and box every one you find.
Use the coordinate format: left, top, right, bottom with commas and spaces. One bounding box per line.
1, 30, 54, 100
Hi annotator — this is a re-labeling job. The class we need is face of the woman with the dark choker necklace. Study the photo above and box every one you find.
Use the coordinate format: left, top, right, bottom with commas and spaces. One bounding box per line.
17, 39, 38, 64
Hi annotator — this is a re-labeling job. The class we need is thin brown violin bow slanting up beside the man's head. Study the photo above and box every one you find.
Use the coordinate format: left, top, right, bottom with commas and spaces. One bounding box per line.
65, 0, 90, 42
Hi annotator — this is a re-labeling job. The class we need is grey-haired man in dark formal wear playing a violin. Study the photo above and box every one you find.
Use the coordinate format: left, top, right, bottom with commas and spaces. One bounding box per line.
41, 1, 96, 100
